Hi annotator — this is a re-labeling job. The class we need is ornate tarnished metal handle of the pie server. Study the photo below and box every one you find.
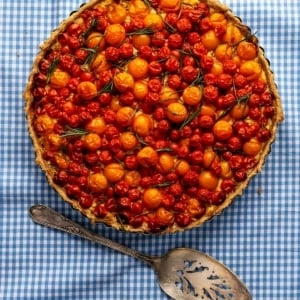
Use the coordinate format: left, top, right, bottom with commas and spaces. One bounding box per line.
29, 204, 156, 265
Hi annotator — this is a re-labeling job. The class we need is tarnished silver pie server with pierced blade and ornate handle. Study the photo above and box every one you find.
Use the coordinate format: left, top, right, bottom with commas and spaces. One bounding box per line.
29, 205, 252, 300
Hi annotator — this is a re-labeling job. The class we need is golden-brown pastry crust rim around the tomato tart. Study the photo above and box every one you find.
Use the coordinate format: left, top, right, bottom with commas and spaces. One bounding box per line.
24, 0, 283, 233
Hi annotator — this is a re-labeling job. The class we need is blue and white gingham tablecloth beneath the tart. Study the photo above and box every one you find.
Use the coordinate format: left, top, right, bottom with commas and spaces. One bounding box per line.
0, 0, 300, 300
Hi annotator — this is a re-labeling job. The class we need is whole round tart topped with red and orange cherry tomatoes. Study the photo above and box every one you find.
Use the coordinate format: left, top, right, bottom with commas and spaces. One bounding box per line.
24, 0, 283, 233
